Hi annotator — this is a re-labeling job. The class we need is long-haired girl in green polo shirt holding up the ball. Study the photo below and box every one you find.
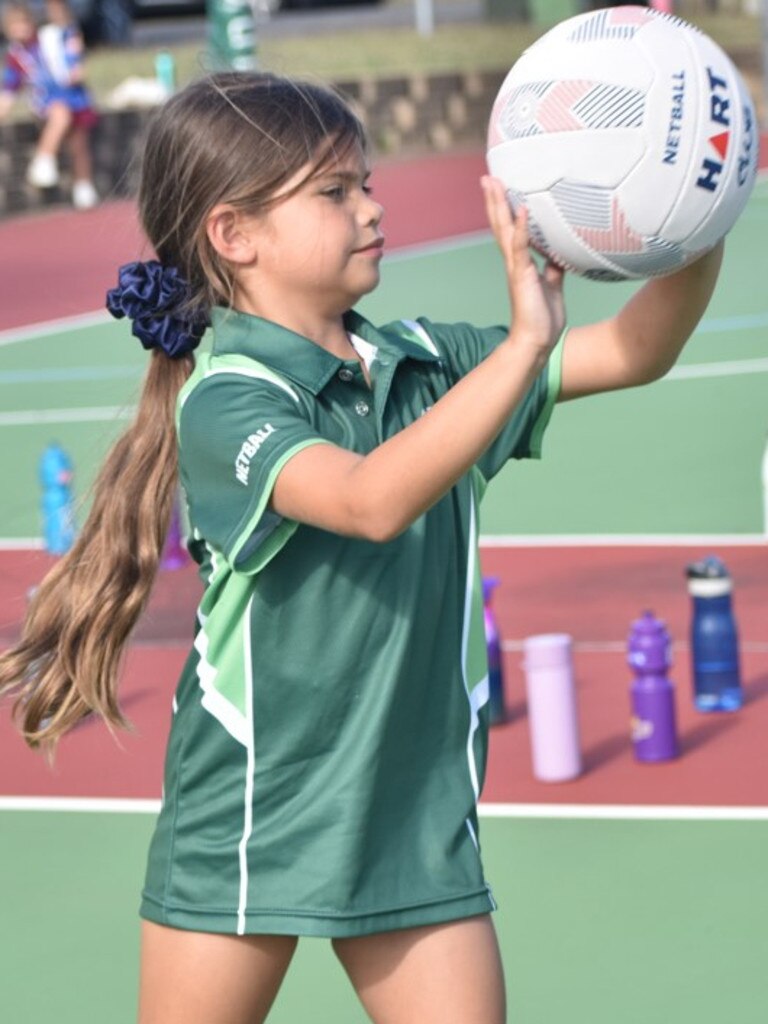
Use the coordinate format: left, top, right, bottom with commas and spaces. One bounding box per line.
0, 74, 721, 1024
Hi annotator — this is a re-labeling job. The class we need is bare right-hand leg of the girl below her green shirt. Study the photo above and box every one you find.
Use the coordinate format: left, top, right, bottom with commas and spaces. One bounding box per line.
334, 914, 506, 1024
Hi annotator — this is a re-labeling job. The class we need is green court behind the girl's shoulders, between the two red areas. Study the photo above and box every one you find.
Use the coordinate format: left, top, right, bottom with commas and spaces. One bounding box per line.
0, 179, 768, 538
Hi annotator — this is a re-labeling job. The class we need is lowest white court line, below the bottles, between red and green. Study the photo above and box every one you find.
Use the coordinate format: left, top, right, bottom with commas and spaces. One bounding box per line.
0, 797, 768, 821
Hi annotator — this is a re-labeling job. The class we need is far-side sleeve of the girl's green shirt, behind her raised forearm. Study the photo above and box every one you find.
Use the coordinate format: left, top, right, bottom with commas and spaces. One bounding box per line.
411, 317, 564, 481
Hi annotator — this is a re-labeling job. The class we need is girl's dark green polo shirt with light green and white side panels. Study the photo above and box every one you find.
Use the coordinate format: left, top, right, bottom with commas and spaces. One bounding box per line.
142, 310, 560, 937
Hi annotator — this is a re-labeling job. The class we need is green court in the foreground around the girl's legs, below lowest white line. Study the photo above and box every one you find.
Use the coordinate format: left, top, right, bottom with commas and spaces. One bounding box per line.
0, 811, 768, 1024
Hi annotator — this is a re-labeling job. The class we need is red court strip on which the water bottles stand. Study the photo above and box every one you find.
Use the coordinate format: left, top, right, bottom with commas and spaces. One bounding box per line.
0, 545, 768, 806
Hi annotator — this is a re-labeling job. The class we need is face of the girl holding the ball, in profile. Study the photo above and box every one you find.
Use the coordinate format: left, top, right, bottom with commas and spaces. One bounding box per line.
236, 146, 384, 327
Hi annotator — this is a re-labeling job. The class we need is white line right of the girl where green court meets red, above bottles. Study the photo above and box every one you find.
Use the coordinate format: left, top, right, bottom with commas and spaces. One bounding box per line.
480, 534, 768, 548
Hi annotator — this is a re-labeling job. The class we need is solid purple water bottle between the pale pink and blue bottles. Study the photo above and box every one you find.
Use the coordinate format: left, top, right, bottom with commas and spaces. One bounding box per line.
627, 611, 678, 761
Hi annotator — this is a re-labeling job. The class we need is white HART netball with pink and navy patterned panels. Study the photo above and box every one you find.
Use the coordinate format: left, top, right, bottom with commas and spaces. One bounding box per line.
487, 6, 758, 281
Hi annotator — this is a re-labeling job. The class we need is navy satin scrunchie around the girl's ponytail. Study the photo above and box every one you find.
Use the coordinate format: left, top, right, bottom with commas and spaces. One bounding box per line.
106, 259, 208, 359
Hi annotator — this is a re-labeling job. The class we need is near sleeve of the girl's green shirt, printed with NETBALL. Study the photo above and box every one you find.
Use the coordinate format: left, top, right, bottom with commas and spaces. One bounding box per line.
178, 374, 329, 573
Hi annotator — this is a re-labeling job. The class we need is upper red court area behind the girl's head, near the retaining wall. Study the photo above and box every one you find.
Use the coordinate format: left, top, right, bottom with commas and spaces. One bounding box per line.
0, 153, 487, 330
